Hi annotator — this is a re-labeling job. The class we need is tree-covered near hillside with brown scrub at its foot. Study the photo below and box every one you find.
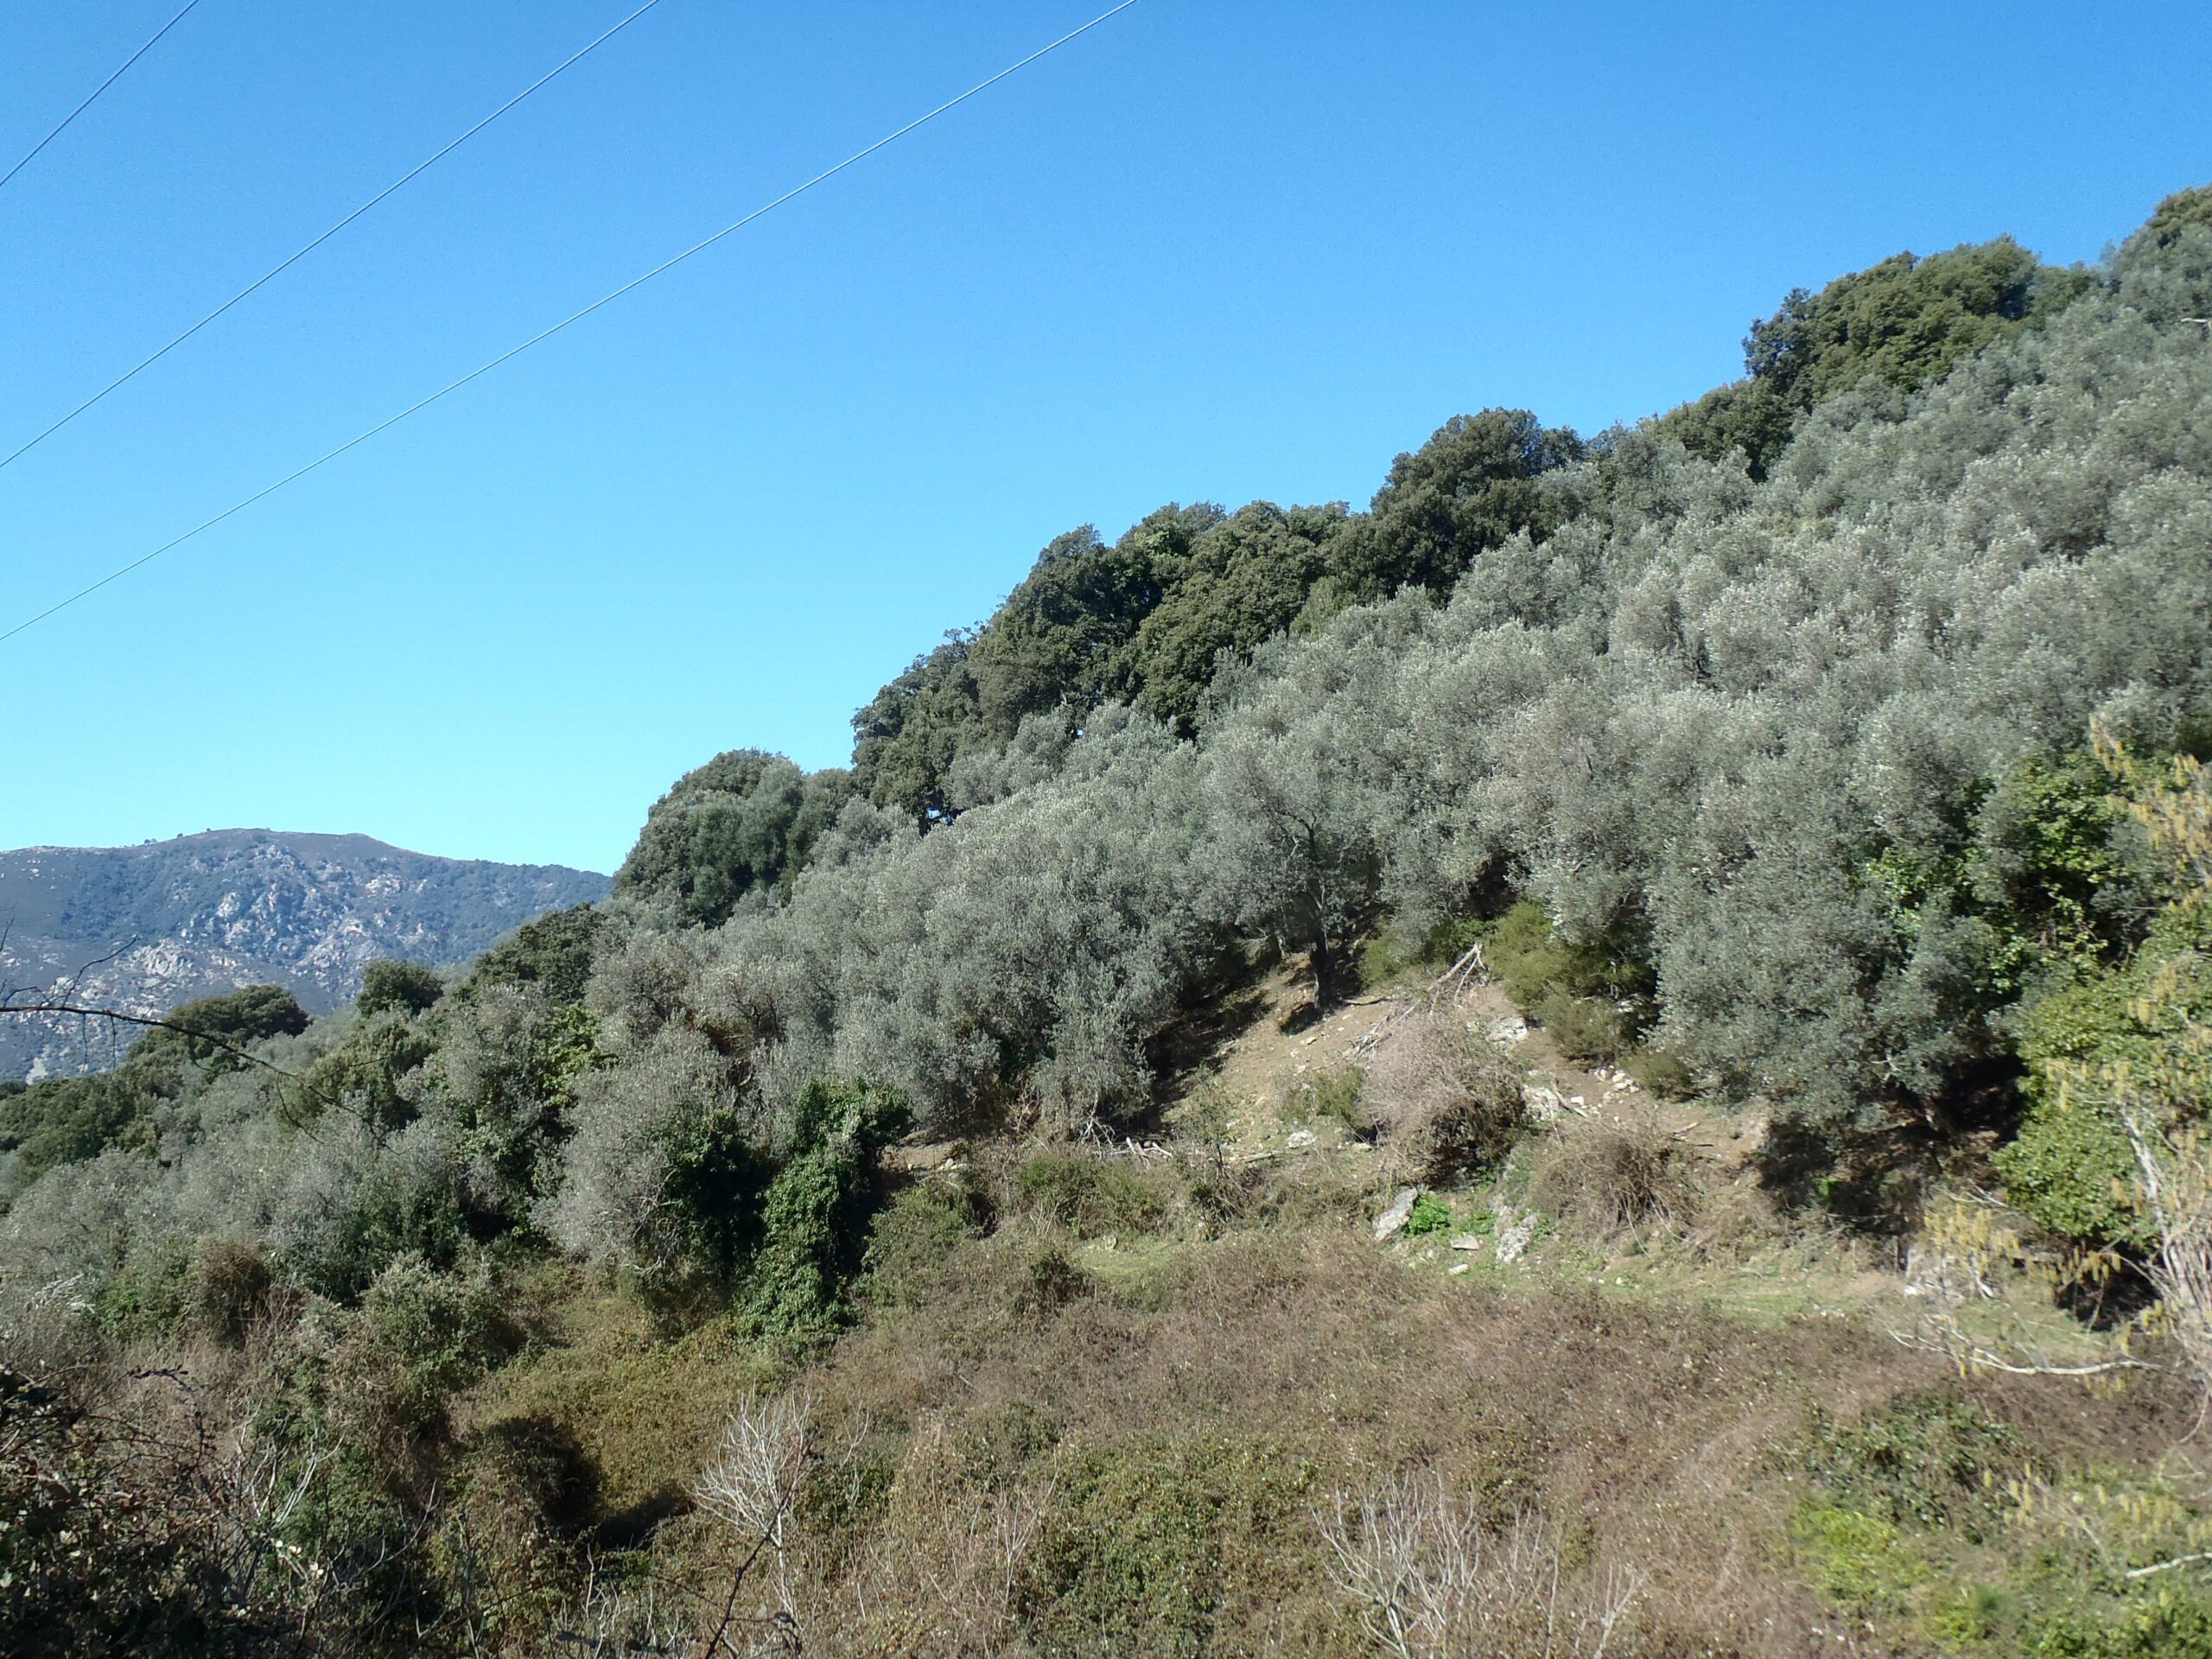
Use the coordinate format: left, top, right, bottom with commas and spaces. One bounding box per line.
0, 190, 2212, 1659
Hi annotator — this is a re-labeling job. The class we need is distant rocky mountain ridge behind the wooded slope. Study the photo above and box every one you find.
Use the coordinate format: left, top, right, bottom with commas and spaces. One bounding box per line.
0, 830, 608, 1092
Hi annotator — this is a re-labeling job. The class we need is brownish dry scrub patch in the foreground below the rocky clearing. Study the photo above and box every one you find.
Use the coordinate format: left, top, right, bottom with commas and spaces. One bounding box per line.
619, 1232, 2141, 1656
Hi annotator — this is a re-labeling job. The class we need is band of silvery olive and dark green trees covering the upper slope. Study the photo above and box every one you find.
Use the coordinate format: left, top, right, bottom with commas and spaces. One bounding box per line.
0, 197, 2212, 1336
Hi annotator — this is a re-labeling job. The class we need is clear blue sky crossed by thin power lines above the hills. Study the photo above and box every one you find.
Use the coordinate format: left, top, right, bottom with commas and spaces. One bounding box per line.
0, 0, 2212, 869
